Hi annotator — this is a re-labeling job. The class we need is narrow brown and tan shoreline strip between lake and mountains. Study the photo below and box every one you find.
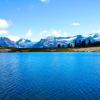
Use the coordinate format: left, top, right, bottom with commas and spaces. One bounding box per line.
0, 47, 100, 53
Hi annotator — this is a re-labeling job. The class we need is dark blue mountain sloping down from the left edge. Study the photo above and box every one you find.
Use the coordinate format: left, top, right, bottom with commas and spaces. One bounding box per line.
0, 37, 18, 47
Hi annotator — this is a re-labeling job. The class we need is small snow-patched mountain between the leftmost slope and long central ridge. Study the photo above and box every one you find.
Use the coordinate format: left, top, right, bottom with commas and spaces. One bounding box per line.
16, 39, 34, 48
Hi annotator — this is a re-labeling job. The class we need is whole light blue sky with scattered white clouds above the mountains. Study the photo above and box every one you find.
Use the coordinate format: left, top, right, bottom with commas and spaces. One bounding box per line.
0, 0, 100, 41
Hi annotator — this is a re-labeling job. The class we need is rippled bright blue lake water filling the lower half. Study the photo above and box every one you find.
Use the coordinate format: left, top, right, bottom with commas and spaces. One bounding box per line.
0, 53, 100, 100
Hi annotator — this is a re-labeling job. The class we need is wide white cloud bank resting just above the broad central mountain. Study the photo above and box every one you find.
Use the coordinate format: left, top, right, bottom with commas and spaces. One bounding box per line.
40, 29, 67, 38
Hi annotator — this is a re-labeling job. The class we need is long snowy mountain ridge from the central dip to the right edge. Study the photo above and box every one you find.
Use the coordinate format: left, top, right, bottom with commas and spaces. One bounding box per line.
33, 33, 100, 48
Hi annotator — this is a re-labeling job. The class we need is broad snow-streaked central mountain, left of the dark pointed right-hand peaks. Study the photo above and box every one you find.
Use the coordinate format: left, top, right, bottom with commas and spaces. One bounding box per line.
34, 37, 74, 48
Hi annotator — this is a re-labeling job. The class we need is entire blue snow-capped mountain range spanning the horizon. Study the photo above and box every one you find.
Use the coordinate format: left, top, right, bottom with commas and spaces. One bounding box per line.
0, 33, 100, 48
